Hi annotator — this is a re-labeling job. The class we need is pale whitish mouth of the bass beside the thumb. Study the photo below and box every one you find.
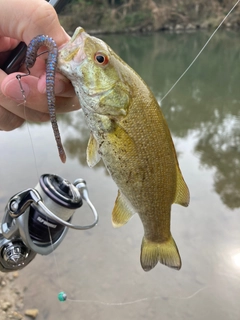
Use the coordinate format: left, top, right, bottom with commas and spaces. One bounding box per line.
58, 27, 88, 66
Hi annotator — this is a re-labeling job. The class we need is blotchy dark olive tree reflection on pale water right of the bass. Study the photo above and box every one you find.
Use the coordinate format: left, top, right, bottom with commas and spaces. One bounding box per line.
195, 115, 240, 209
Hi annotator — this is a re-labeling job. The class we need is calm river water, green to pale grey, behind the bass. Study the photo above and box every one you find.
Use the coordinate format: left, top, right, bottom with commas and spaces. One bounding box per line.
0, 31, 240, 320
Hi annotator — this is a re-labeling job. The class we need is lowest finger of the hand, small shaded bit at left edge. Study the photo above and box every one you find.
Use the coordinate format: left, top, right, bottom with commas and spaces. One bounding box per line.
0, 106, 24, 131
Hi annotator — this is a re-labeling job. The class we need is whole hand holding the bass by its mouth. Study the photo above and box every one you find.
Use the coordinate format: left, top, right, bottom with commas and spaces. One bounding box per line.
0, 0, 80, 131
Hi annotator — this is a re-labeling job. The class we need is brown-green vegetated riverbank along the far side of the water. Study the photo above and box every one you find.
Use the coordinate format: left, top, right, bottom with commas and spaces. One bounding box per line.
60, 0, 240, 33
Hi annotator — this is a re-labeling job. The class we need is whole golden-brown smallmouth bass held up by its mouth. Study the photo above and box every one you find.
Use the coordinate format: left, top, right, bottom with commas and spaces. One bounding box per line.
58, 27, 190, 271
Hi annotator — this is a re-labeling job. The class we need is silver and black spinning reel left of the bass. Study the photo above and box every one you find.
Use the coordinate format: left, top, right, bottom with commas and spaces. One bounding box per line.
0, 174, 98, 272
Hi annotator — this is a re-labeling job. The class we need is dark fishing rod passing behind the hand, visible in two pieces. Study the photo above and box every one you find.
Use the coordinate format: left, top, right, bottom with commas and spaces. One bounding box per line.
0, 0, 69, 74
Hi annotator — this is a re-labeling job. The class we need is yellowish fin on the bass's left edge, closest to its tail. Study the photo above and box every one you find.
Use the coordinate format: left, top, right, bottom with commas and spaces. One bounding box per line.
112, 191, 135, 228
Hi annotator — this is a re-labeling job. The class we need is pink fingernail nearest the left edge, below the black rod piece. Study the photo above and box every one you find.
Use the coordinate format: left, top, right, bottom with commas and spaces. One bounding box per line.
2, 79, 29, 100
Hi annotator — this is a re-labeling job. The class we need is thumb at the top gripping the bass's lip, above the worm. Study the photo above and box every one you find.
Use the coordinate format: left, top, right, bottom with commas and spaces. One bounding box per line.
0, 0, 69, 46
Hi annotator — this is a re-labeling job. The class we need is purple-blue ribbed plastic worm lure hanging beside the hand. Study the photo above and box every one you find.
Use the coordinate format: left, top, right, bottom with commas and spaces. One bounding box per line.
25, 35, 66, 163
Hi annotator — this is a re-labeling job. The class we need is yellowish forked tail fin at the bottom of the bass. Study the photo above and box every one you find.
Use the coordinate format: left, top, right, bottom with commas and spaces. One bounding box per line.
140, 235, 182, 271
